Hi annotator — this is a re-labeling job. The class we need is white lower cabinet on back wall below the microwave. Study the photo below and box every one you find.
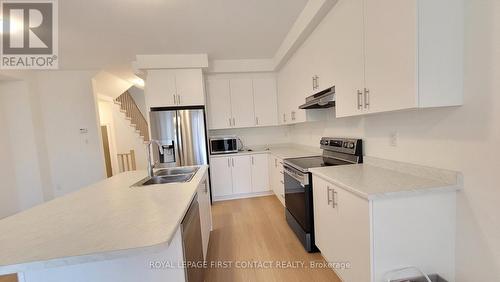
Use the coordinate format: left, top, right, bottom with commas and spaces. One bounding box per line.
210, 154, 270, 201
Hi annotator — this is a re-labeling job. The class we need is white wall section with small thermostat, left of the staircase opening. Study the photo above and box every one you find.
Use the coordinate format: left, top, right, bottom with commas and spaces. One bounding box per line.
36, 71, 105, 196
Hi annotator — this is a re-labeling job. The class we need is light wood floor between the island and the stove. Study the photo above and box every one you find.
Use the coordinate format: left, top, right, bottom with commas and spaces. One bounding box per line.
205, 196, 340, 282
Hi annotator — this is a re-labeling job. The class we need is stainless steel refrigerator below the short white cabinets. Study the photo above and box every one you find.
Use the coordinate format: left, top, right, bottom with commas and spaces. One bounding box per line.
149, 107, 208, 167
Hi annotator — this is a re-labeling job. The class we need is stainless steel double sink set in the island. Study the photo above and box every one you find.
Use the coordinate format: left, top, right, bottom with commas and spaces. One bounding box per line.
132, 167, 199, 187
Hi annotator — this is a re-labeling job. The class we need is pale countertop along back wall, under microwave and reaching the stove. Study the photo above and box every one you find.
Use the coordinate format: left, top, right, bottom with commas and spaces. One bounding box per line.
210, 144, 321, 159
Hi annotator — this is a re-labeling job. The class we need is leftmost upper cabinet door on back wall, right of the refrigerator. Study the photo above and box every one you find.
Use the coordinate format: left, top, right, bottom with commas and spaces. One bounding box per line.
207, 79, 232, 129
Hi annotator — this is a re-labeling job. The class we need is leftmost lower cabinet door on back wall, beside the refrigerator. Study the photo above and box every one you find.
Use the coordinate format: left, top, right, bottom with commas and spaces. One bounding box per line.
210, 157, 233, 197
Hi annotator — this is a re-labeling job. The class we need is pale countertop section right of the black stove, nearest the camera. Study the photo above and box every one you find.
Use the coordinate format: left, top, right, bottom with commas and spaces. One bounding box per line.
310, 158, 463, 200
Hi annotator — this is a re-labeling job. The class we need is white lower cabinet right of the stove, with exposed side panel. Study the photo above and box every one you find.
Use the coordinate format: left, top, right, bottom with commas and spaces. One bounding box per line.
313, 175, 456, 282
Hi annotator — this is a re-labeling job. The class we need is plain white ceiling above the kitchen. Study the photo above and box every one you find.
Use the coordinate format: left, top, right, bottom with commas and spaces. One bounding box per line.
59, 0, 307, 69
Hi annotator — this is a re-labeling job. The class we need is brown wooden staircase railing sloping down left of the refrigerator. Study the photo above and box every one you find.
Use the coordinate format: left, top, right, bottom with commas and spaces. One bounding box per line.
115, 91, 149, 142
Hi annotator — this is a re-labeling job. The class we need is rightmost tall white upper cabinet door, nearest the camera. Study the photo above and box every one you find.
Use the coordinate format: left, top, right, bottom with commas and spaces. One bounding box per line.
364, 0, 419, 113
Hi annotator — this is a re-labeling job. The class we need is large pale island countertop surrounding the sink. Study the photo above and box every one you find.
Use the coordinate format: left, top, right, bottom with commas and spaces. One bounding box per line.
0, 166, 207, 273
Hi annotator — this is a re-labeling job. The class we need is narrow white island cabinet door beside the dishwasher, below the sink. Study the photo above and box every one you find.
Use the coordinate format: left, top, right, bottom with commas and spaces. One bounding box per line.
198, 178, 212, 260
